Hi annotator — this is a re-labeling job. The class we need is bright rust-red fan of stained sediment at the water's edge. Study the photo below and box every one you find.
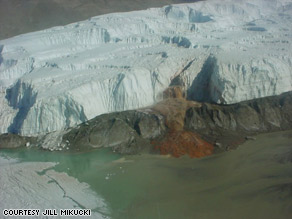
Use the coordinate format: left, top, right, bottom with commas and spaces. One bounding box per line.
153, 131, 214, 158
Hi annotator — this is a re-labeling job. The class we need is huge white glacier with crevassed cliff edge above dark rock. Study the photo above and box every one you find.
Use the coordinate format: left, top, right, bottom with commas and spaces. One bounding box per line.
0, 0, 292, 136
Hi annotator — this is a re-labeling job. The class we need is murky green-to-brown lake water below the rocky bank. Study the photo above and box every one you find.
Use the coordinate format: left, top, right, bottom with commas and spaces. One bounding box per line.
0, 131, 292, 219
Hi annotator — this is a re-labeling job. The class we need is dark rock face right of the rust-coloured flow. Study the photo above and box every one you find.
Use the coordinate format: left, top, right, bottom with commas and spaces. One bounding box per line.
185, 92, 292, 150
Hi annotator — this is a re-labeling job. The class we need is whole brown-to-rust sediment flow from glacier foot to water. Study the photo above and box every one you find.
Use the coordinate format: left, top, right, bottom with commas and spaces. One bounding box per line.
152, 86, 214, 157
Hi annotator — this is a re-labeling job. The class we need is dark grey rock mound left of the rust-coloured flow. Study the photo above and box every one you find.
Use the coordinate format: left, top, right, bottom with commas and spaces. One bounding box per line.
62, 111, 165, 154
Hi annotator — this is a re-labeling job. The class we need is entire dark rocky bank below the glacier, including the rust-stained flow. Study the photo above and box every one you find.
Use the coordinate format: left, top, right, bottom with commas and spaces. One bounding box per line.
0, 90, 292, 157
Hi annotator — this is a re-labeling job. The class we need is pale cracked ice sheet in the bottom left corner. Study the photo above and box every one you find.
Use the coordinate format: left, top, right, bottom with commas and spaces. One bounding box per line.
0, 156, 109, 218
